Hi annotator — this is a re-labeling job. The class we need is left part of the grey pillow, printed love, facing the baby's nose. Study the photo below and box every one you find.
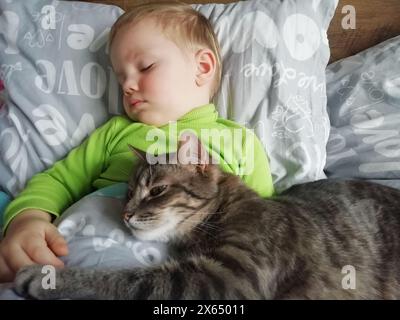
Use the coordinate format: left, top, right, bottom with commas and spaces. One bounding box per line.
0, 0, 123, 196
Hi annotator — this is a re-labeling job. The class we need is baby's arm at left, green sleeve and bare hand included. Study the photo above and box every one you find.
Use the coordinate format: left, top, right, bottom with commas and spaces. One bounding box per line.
0, 121, 113, 282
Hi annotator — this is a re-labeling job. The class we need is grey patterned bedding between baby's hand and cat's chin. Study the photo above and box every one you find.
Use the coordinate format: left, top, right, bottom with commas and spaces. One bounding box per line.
55, 183, 168, 268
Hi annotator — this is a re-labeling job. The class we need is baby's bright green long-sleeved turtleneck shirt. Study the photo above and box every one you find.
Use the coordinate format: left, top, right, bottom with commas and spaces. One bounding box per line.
3, 104, 274, 230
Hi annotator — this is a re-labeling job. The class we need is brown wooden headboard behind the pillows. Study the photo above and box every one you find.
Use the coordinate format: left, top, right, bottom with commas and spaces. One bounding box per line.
86, 0, 400, 62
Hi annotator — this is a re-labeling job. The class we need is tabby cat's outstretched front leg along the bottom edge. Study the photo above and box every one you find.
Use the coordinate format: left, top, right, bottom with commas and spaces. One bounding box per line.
15, 256, 265, 300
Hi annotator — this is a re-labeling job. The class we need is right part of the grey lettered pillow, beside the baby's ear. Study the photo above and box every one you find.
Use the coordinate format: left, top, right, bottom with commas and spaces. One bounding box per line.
194, 0, 338, 192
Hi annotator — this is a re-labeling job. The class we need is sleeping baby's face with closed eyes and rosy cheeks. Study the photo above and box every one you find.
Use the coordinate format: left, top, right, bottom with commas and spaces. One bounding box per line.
110, 19, 209, 126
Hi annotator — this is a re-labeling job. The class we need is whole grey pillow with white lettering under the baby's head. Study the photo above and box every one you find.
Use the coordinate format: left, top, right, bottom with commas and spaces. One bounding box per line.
0, 0, 338, 195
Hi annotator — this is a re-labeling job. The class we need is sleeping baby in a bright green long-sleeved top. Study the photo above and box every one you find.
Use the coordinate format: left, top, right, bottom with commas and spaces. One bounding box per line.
0, 2, 273, 282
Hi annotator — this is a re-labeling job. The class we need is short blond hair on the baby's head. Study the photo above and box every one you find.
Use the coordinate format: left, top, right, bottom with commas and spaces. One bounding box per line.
109, 1, 222, 98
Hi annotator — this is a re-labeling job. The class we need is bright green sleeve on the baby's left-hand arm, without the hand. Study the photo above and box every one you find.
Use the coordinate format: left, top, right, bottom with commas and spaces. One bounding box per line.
3, 120, 114, 231
